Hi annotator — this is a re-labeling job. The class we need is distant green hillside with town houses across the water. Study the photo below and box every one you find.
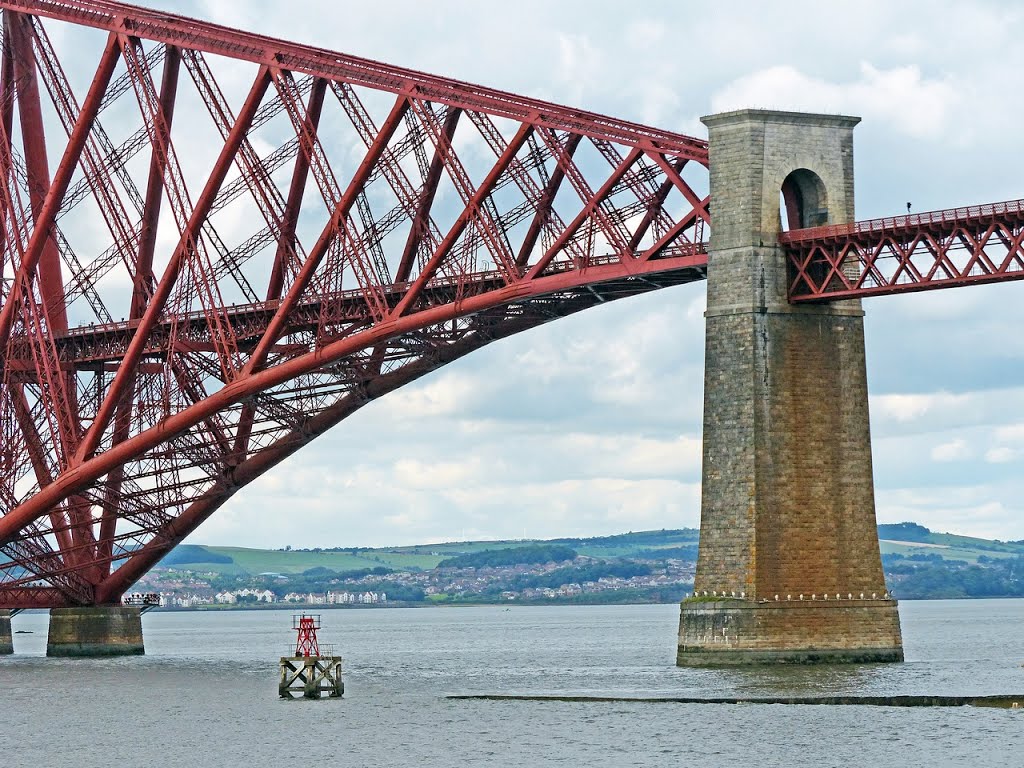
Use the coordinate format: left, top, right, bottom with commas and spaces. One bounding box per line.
128, 523, 1024, 609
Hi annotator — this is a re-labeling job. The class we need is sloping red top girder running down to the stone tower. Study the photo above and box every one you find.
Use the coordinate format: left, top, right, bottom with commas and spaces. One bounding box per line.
0, 0, 708, 164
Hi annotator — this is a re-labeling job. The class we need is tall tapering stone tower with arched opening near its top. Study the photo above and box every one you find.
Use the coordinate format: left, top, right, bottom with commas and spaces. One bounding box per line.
677, 110, 903, 666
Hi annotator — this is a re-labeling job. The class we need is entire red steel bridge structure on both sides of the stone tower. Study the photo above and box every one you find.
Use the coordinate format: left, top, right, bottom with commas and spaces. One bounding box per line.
0, 0, 1024, 608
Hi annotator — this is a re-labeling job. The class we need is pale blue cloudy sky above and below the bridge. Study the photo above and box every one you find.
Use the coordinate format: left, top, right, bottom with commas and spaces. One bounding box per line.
112, 0, 1024, 547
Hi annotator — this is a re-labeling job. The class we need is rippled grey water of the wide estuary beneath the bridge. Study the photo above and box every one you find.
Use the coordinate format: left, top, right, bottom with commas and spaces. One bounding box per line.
0, 600, 1024, 768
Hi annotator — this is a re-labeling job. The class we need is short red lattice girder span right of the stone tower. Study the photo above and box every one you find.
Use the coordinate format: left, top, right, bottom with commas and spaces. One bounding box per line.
779, 200, 1024, 302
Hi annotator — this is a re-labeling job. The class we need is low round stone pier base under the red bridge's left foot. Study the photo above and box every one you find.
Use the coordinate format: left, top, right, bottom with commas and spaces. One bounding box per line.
46, 606, 145, 656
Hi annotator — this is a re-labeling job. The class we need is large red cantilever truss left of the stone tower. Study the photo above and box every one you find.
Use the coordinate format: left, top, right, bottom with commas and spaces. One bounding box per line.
0, 0, 708, 604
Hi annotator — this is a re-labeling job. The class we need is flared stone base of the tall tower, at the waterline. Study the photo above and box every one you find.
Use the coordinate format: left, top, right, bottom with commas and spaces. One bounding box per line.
676, 598, 903, 667
